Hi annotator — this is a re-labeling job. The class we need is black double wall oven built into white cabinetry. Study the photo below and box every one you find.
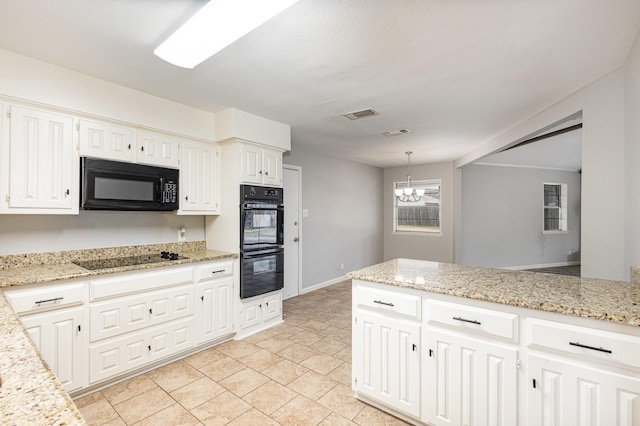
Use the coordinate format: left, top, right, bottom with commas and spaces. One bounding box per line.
240, 185, 284, 299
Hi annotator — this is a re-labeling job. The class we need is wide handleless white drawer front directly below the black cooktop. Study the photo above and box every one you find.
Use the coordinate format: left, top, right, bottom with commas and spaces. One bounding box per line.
90, 266, 193, 301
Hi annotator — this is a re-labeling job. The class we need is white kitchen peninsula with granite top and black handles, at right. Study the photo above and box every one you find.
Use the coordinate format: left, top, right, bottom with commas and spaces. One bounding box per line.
347, 259, 640, 425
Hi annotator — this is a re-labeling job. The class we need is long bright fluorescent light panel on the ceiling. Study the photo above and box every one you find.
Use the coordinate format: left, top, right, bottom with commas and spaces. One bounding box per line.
153, 0, 298, 68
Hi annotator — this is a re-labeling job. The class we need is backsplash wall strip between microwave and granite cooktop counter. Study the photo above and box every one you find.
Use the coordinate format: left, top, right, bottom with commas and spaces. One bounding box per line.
0, 211, 204, 255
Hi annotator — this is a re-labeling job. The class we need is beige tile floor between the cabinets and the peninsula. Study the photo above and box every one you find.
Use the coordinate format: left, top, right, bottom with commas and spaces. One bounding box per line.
75, 281, 405, 426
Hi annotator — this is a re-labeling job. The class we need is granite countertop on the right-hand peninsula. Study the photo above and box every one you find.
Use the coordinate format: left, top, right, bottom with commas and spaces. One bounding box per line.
347, 259, 640, 326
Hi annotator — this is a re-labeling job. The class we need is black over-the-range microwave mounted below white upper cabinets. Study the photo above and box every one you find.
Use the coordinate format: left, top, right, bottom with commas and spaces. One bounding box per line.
80, 157, 179, 211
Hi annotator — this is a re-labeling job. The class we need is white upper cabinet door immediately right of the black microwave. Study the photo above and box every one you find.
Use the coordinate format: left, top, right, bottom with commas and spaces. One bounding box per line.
179, 141, 220, 215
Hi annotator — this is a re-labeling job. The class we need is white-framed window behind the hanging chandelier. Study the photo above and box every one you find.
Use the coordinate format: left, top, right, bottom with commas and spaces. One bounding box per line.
393, 179, 442, 234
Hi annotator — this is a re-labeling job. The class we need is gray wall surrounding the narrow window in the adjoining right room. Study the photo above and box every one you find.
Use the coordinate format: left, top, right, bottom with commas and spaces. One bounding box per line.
459, 165, 581, 267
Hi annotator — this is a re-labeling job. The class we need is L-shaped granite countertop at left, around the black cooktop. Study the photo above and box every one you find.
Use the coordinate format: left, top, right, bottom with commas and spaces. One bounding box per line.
0, 241, 238, 425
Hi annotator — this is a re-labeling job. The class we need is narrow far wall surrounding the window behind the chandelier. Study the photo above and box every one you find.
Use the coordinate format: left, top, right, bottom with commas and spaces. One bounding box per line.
384, 163, 455, 262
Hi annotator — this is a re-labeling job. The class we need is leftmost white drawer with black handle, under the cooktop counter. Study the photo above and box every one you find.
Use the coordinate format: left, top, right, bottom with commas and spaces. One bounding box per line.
5, 282, 86, 314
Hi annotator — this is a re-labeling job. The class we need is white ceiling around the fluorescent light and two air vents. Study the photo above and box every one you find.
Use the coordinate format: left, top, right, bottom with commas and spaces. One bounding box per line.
0, 0, 640, 167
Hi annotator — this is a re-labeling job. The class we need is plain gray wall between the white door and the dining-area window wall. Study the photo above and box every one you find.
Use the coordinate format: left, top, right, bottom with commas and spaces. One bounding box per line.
284, 142, 383, 291
